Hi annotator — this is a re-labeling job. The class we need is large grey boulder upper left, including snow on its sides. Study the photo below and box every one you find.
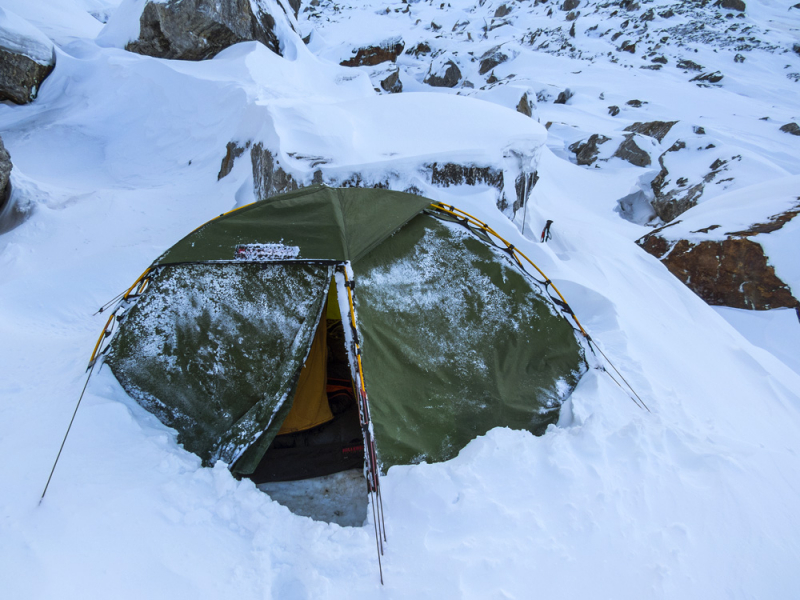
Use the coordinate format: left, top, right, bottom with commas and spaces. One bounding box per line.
98, 0, 295, 60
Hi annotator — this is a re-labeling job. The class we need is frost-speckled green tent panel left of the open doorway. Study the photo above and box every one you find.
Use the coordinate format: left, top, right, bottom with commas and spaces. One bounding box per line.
107, 264, 331, 472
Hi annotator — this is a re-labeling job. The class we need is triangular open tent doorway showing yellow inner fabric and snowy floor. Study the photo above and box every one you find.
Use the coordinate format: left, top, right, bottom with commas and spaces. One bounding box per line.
248, 281, 367, 525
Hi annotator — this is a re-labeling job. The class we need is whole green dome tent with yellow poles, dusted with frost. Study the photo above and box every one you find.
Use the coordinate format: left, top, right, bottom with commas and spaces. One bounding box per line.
96, 186, 586, 500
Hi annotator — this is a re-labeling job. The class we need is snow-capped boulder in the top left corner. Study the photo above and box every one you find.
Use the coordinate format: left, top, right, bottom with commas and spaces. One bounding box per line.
0, 8, 55, 104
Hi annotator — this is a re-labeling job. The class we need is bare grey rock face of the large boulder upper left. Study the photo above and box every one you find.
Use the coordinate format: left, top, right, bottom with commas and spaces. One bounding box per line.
125, 0, 291, 60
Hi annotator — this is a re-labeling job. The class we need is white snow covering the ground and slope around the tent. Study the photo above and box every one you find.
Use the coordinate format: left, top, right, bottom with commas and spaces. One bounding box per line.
0, 0, 800, 600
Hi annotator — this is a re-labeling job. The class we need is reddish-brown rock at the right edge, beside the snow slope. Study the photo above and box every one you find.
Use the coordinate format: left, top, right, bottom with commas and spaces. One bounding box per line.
636, 208, 800, 310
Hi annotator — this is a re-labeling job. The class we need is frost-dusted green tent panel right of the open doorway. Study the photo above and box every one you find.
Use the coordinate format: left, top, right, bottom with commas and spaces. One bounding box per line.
353, 216, 586, 469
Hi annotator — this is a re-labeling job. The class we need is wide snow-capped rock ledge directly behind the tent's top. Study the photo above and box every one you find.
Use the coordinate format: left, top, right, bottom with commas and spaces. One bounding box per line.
228, 93, 545, 216
